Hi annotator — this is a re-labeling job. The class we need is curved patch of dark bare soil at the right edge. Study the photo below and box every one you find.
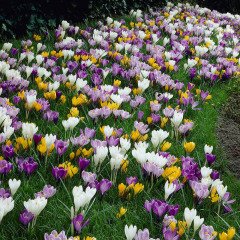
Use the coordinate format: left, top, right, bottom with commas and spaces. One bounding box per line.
217, 92, 240, 178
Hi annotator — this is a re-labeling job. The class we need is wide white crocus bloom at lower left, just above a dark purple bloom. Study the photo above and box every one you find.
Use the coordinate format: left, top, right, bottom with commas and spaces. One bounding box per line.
23, 197, 48, 218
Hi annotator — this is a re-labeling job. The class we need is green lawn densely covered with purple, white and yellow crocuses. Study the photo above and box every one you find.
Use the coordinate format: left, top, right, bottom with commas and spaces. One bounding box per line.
0, 3, 240, 240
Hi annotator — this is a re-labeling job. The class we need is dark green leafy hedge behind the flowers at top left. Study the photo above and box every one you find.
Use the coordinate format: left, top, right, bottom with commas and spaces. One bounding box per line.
0, 0, 165, 38
